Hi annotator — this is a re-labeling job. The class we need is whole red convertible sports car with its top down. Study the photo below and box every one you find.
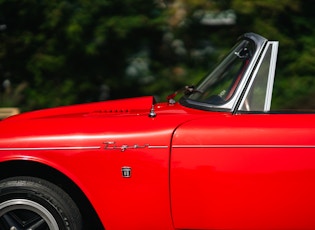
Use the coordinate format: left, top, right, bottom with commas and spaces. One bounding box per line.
0, 33, 315, 230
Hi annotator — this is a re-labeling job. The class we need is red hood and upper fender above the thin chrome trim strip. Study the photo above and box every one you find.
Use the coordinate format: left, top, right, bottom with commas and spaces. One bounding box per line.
0, 97, 216, 148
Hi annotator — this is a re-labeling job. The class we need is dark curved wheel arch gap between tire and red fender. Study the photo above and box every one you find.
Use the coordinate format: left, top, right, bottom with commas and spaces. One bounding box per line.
0, 160, 104, 230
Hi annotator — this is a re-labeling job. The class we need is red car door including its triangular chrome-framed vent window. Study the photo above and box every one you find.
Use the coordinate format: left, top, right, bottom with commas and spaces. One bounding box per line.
170, 42, 315, 229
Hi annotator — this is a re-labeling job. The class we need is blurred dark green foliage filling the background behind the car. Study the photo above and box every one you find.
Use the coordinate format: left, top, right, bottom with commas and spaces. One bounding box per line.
0, 0, 315, 111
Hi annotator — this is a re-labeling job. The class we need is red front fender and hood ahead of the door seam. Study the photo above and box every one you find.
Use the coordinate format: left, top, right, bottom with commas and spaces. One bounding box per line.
0, 97, 207, 229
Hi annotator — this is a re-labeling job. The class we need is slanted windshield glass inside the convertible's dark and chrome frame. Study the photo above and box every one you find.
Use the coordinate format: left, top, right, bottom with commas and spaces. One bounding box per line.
186, 40, 254, 105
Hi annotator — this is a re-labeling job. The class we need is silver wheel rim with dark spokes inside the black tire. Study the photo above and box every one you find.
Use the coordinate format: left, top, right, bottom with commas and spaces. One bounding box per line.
0, 199, 59, 230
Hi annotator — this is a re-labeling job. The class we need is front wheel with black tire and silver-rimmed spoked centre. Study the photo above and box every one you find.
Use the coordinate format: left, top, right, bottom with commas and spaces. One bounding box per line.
0, 177, 82, 230
